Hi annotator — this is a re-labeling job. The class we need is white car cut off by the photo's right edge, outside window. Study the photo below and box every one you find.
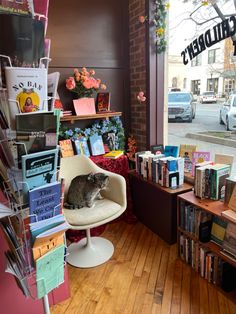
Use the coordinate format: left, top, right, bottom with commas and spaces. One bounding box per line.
220, 95, 236, 131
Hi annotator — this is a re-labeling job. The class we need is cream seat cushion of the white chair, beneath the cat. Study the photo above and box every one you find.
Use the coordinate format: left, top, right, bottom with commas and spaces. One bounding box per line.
63, 198, 121, 229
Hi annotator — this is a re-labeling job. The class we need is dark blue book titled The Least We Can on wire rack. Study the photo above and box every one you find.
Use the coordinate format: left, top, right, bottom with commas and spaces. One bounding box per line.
29, 182, 61, 222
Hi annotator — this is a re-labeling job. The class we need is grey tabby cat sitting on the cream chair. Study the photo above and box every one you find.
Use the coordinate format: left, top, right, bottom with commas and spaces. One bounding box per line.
64, 172, 109, 209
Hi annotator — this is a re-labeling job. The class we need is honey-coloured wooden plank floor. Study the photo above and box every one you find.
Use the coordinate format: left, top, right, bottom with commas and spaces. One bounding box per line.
51, 221, 236, 314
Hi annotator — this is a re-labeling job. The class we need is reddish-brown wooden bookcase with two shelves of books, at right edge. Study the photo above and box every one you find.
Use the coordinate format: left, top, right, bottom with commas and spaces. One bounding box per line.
177, 191, 236, 300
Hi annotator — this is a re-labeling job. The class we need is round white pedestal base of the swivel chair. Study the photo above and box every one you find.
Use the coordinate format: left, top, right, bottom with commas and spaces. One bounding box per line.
66, 237, 114, 268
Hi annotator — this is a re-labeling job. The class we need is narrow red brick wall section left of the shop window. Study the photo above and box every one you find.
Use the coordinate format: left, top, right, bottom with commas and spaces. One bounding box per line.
129, 0, 147, 150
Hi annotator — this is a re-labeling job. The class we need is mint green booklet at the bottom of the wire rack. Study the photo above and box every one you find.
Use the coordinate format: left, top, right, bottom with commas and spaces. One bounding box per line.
36, 244, 65, 299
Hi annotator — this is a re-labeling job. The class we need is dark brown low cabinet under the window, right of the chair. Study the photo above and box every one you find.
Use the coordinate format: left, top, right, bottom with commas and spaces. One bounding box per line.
129, 170, 192, 244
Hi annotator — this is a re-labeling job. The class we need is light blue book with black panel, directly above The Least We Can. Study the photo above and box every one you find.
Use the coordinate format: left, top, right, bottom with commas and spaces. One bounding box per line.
21, 148, 58, 195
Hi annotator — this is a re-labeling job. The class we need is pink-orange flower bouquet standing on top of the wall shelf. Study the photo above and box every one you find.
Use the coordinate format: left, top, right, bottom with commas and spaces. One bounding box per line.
66, 67, 106, 98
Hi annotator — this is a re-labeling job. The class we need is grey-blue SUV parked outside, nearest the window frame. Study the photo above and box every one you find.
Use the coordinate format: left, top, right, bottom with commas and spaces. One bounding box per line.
168, 92, 196, 122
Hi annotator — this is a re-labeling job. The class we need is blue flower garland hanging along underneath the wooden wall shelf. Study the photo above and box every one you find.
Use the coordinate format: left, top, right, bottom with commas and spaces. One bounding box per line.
59, 117, 125, 150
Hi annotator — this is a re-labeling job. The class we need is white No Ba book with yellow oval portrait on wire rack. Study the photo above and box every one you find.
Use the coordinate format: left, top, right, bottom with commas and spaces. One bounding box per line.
5, 67, 48, 129
